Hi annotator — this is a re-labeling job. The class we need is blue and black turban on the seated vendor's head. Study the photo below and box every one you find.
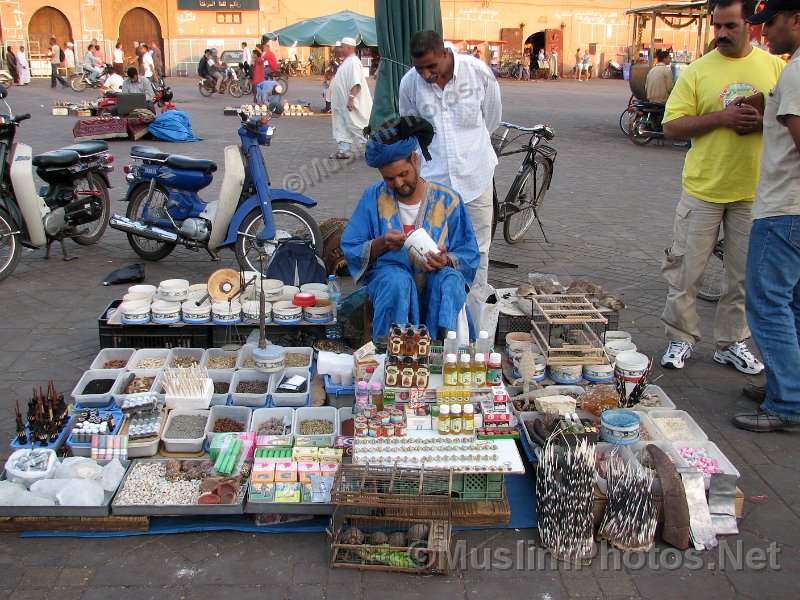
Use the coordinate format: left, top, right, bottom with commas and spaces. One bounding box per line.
364, 116, 433, 169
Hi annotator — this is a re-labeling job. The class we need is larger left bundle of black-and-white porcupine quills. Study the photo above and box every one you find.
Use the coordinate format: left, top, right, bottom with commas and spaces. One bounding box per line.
536, 439, 595, 564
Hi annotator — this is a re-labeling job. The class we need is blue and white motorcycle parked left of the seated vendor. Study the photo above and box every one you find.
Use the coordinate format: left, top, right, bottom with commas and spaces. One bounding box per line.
110, 110, 322, 273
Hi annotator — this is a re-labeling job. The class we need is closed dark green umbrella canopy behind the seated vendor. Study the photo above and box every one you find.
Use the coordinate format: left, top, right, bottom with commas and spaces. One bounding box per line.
369, 0, 442, 129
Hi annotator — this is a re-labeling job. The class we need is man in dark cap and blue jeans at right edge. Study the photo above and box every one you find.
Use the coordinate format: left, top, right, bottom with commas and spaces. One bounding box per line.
733, 0, 800, 432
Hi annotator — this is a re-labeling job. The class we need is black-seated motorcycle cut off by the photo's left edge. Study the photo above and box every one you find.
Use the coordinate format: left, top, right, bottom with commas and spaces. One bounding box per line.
0, 86, 114, 281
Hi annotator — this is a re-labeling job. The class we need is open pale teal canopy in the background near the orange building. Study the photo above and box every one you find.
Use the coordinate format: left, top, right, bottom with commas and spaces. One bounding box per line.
269, 10, 378, 46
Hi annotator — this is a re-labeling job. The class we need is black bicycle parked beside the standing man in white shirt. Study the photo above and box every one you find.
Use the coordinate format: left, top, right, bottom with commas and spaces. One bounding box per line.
492, 123, 557, 244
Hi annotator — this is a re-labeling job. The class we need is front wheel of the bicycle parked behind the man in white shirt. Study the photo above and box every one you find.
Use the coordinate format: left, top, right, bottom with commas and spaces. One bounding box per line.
503, 156, 553, 244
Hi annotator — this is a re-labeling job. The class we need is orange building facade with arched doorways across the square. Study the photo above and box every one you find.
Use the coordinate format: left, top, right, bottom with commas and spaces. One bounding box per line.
0, 0, 696, 76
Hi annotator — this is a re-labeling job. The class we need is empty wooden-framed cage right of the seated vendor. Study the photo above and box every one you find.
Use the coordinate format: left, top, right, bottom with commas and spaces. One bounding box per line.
531, 294, 608, 365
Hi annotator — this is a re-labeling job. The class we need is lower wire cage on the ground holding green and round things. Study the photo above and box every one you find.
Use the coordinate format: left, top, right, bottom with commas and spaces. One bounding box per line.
328, 506, 451, 575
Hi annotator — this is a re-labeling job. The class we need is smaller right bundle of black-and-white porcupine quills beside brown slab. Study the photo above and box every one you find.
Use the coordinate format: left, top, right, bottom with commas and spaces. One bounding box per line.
598, 460, 658, 552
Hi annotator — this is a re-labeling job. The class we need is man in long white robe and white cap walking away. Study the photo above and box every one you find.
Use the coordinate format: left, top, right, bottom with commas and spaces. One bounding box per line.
331, 37, 372, 159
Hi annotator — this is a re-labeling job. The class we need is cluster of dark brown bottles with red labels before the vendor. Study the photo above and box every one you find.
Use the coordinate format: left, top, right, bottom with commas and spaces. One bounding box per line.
384, 323, 431, 388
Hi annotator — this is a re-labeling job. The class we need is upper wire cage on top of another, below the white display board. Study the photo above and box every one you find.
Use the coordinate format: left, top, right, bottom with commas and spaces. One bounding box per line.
331, 465, 452, 518
